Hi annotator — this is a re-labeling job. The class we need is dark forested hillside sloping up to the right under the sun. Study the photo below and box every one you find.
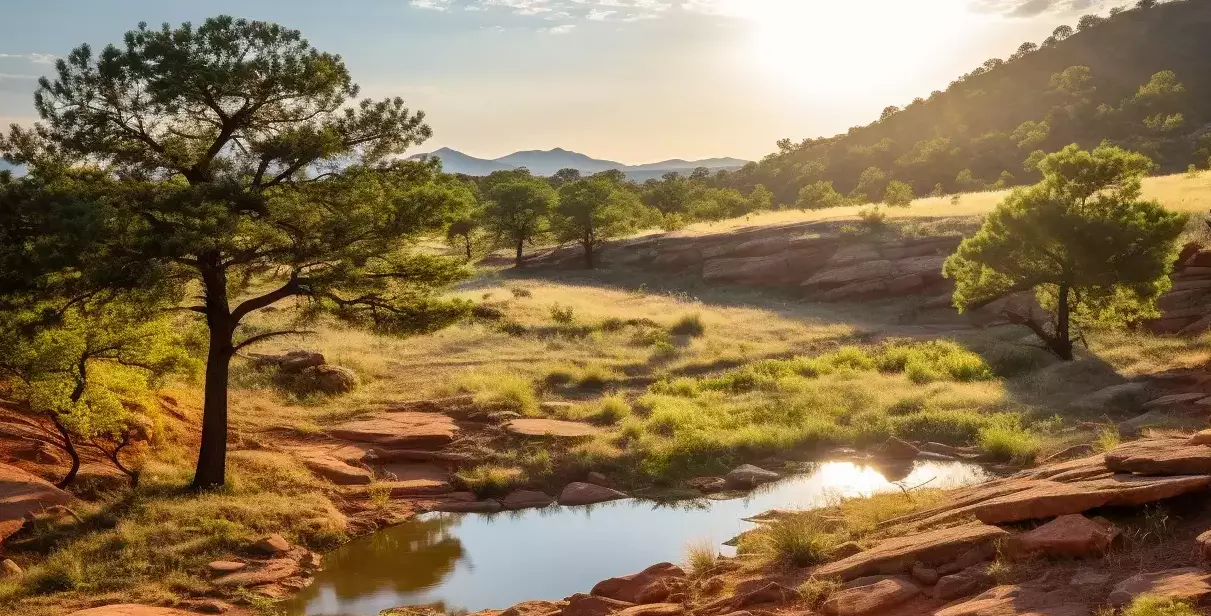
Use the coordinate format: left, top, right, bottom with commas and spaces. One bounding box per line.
712, 0, 1211, 207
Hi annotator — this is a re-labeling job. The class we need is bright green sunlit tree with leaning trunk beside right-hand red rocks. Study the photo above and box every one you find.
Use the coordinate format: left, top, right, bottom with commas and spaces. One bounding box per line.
943, 145, 1186, 359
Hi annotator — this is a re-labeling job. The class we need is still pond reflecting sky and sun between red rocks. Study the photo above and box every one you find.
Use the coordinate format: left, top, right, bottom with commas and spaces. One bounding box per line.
287, 461, 989, 616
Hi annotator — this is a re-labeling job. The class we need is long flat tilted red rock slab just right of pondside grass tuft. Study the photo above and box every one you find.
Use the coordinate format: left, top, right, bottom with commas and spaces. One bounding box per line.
814, 524, 1009, 581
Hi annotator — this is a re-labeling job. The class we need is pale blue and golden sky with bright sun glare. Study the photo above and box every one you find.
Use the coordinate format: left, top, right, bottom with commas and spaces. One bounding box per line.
0, 0, 1127, 165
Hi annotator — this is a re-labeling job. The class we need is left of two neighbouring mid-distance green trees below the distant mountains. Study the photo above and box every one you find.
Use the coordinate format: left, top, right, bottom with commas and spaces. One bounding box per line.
484, 177, 558, 267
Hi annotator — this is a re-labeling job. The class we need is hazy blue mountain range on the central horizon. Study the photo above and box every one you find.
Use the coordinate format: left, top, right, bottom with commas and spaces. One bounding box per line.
412, 148, 748, 182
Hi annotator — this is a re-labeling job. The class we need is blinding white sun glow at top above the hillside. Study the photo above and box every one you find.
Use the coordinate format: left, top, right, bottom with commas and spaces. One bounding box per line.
716, 0, 978, 96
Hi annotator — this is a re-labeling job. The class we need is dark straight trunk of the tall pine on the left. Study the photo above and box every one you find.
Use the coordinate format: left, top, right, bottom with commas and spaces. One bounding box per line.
193, 255, 236, 490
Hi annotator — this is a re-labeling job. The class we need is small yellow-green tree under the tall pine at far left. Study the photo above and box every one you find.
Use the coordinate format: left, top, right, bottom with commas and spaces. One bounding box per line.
0, 292, 193, 488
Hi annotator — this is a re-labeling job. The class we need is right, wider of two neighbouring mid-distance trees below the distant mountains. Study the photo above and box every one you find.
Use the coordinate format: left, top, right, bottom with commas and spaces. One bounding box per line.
552, 178, 644, 270
